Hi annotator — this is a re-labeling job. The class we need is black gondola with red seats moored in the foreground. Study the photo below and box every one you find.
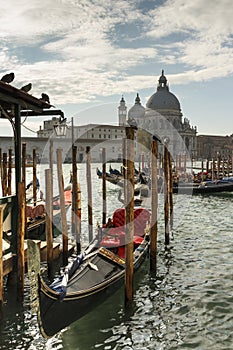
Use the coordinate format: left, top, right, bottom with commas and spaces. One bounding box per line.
29, 208, 150, 337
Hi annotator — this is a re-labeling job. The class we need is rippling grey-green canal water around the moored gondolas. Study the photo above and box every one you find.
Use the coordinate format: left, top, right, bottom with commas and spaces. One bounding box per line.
0, 164, 233, 350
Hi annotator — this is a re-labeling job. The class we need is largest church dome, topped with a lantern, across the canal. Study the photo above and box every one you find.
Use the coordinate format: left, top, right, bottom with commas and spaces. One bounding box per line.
146, 70, 180, 111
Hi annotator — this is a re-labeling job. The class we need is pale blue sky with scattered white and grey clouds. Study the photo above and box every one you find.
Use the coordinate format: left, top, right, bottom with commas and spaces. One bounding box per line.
0, 0, 233, 136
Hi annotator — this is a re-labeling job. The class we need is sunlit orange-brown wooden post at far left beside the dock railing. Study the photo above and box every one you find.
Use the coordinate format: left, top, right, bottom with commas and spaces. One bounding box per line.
17, 182, 26, 300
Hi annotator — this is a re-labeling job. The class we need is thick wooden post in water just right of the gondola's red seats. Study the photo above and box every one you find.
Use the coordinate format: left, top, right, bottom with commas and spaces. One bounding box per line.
150, 140, 158, 272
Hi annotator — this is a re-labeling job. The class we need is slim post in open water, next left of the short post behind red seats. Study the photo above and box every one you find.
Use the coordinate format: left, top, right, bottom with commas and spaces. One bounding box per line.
86, 146, 93, 242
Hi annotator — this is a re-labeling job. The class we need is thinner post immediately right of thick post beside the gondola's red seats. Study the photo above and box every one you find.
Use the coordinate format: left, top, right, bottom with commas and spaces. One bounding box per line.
163, 143, 170, 245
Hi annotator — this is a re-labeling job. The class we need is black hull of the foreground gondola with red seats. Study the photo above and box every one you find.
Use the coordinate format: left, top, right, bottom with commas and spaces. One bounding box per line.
38, 240, 149, 337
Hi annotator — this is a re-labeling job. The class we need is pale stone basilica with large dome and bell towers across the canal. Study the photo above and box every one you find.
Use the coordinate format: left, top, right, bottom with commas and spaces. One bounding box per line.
118, 71, 197, 157
